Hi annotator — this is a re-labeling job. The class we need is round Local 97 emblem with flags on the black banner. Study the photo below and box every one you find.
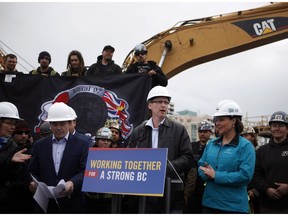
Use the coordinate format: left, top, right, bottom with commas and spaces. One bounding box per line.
34, 85, 133, 138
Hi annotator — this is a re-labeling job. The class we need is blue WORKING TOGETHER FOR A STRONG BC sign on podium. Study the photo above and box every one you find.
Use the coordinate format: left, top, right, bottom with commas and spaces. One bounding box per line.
82, 148, 168, 196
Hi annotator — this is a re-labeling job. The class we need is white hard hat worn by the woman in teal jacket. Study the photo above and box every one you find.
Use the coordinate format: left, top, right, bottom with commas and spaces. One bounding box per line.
213, 100, 243, 117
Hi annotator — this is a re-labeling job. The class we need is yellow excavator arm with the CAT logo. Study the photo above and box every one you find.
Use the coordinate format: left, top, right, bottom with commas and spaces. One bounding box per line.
123, 2, 288, 79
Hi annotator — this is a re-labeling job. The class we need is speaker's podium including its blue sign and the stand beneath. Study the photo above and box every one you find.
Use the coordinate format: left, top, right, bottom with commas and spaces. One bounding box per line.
82, 148, 178, 214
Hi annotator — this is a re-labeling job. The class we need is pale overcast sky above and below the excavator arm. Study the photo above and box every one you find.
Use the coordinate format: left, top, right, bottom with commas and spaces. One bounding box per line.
0, 2, 288, 120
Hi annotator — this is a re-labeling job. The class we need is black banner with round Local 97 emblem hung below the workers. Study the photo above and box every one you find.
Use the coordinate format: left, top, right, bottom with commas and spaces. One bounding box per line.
0, 74, 151, 141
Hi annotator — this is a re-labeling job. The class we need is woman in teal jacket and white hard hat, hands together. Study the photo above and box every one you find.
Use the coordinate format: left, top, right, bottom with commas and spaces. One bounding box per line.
198, 100, 255, 213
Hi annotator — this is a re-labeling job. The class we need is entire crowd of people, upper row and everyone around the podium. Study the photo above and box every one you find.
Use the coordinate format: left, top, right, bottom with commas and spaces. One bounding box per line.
0, 44, 288, 214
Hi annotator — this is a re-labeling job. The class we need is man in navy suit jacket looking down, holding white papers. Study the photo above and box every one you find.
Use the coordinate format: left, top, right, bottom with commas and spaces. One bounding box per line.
30, 102, 89, 213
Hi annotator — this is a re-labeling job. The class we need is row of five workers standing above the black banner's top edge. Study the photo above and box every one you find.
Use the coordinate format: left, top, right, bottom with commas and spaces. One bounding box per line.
0, 44, 168, 87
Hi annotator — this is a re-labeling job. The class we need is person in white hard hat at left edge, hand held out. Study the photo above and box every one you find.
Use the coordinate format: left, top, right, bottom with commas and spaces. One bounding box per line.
0, 102, 31, 213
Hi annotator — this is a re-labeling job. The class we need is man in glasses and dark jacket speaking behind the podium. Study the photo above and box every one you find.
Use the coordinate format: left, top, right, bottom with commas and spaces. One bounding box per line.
128, 86, 193, 213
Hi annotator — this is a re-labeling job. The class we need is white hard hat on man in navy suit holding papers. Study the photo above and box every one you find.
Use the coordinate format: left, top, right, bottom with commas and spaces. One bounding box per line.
45, 102, 75, 122
